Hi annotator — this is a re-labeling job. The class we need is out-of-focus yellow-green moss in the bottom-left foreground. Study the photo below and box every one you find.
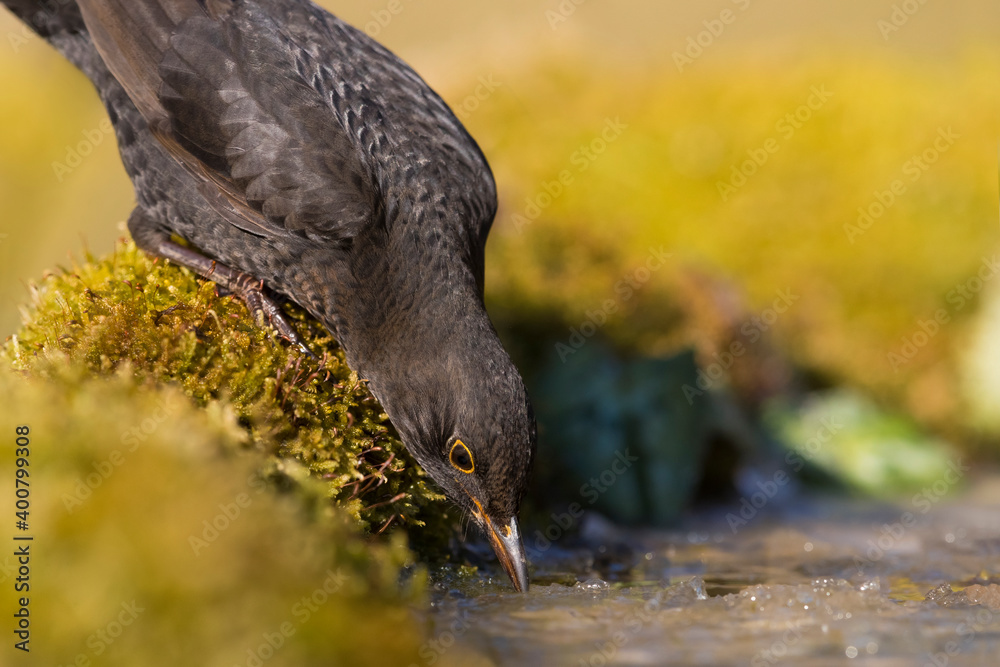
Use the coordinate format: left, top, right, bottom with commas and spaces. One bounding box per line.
0, 364, 424, 667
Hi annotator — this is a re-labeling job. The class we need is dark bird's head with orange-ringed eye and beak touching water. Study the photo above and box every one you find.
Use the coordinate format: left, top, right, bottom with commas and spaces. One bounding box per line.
354, 298, 536, 591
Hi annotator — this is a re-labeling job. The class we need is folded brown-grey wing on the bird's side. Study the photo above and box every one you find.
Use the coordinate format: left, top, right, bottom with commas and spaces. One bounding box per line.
79, 0, 377, 241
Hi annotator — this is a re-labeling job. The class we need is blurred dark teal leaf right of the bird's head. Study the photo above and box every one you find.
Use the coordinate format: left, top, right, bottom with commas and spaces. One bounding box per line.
533, 341, 712, 525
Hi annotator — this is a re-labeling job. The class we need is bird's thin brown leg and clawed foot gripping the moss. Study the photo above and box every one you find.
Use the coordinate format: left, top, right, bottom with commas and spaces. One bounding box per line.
128, 208, 315, 357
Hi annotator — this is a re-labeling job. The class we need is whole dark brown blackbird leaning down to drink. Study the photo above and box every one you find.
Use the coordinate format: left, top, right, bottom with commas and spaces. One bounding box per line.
3, 0, 536, 591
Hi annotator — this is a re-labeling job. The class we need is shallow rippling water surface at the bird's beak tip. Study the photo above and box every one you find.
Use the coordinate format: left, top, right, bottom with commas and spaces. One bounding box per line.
422, 480, 1000, 667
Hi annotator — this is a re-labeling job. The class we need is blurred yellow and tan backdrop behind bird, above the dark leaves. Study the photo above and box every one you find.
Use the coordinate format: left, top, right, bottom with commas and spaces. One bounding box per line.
0, 0, 1000, 438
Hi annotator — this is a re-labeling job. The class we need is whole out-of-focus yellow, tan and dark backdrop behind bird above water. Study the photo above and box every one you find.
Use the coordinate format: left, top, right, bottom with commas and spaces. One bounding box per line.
0, 0, 1000, 544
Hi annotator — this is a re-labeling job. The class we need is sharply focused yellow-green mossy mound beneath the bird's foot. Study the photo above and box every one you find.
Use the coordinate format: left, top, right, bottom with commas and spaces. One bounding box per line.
3, 242, 454, 540
